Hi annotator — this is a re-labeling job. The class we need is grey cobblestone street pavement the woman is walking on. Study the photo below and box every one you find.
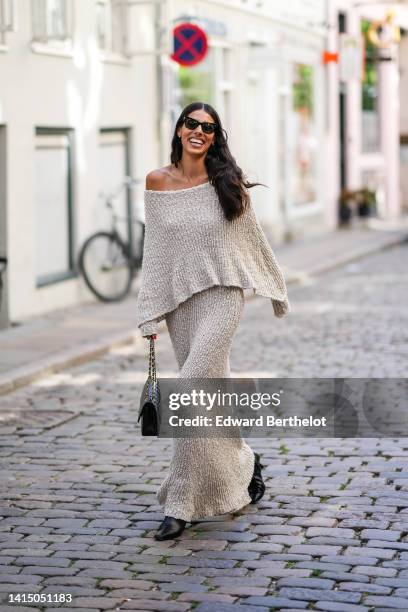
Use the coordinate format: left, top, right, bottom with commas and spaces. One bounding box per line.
0, 241, 408, 612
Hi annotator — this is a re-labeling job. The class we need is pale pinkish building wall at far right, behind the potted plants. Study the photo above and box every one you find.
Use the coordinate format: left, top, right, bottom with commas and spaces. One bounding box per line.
327, 0, 408, 219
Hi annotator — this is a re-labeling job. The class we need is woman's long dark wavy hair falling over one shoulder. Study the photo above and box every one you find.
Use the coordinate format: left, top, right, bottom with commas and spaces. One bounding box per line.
170, 102, 263, 220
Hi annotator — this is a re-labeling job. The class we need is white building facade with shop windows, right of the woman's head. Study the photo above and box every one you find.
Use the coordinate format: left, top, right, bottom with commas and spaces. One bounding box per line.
163, 0, 328, 243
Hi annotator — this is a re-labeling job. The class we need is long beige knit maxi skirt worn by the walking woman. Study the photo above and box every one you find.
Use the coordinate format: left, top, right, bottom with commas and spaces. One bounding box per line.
157, 285, 254, 521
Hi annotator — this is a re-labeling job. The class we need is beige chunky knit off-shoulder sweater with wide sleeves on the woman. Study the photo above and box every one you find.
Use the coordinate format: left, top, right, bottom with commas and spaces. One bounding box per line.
136, 182, 290, 335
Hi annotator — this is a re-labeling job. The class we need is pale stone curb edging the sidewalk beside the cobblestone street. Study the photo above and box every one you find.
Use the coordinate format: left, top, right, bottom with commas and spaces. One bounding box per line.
0, 232, 408, 395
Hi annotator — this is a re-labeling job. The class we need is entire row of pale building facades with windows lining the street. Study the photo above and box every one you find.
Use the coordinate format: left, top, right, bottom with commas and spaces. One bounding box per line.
0, 0, 408, 325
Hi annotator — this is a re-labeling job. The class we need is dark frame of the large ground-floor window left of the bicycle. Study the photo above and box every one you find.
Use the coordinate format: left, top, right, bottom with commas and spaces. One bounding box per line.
35, 126, 78, 288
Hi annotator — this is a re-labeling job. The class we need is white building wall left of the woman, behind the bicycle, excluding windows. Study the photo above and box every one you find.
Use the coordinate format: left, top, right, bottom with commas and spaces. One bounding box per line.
0, 0, 158, 321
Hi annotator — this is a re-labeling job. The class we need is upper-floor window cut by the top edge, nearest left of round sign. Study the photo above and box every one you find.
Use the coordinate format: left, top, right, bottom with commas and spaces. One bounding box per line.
96, 0, 128, 55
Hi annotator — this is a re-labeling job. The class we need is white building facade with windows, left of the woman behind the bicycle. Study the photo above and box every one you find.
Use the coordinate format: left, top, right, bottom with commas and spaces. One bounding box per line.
0, 0, 158, 322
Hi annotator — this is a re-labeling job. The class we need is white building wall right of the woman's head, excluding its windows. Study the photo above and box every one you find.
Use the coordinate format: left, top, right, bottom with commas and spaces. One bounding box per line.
164, 0, 329, 242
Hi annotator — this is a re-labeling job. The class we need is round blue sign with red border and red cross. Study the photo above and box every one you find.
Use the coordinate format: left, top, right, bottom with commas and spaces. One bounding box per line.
171, 22, 208, 66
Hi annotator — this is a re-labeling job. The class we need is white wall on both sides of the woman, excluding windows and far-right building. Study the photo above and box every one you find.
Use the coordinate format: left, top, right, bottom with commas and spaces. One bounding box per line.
0, 0, 333, 321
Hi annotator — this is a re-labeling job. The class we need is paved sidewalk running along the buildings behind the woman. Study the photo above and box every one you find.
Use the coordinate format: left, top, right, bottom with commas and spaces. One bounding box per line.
0, 218, 408, 394
